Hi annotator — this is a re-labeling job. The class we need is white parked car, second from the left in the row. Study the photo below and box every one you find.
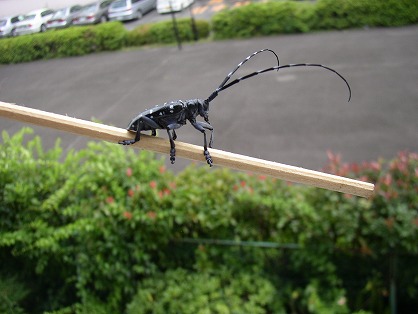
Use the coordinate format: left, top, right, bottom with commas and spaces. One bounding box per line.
15, 9, 54, 35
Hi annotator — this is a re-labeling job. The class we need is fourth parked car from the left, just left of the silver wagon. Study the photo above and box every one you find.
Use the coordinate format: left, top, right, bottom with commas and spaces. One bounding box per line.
73, 0, 113, 25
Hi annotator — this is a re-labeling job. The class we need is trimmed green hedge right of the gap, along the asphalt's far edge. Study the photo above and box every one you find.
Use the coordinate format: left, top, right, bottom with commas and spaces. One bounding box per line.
212, 0, 418, 39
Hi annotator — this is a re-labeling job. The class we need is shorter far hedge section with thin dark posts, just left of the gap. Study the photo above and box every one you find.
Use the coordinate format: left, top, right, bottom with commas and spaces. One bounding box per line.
127, 18, 209, 46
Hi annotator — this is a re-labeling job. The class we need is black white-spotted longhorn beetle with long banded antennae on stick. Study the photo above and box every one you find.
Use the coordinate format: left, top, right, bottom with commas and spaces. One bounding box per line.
119, 49, 351, 167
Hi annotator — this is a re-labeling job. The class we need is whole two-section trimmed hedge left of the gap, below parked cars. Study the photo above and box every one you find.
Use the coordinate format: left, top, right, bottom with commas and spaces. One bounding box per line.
0, 19, 209, 64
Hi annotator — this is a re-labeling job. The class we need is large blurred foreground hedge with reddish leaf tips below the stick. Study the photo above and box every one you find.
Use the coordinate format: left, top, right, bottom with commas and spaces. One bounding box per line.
0, 129, 418, 314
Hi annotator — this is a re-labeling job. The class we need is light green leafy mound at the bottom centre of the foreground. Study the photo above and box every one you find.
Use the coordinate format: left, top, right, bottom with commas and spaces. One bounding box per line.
127, 269, 284, 314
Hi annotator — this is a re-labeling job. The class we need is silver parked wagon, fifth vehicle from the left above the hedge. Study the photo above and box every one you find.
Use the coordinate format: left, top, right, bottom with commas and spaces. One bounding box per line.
109, 0, 157, 21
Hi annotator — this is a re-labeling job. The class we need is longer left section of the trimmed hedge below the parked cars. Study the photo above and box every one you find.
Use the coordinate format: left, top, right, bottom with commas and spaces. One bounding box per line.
0, 22, 127, 63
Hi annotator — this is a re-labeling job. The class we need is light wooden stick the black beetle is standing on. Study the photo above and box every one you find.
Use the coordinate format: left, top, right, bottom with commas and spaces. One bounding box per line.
0, 102, 374, 198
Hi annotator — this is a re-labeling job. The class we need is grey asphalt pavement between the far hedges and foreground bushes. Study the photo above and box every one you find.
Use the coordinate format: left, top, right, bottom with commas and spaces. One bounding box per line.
0, 25, 418, 169
